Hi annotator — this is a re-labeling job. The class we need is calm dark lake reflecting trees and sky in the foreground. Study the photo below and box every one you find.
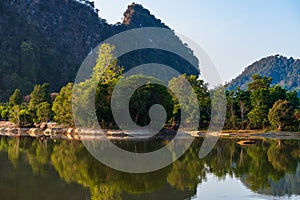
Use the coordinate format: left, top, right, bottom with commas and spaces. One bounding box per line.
0, 137, 300, 200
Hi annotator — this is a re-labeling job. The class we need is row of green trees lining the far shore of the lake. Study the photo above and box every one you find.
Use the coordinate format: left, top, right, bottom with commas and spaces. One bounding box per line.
0, 44, 300, 132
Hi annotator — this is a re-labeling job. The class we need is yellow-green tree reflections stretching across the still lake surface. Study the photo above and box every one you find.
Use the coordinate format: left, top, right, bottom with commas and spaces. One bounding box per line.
0, 138, 300, 199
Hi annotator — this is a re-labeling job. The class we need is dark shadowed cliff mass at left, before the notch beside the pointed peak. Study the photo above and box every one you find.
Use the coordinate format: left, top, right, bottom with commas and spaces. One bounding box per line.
0, 0, 110, 99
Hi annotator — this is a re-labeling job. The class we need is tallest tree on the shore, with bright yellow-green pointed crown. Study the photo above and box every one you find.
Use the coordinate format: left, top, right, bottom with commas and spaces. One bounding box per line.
74, 43, 123, 128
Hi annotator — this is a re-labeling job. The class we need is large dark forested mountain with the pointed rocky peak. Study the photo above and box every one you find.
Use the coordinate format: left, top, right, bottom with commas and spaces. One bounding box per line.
0, 0, 199, 101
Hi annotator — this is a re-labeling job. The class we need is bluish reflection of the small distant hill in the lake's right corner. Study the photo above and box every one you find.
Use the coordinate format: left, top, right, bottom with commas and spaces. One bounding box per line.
241, 163, 300, 196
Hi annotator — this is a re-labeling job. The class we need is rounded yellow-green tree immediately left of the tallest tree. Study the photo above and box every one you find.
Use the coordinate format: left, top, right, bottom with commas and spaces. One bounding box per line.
52, 83, 74, 125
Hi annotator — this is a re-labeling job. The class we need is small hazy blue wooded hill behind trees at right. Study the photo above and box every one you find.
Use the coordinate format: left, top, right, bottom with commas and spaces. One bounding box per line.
227, 55, 300, 92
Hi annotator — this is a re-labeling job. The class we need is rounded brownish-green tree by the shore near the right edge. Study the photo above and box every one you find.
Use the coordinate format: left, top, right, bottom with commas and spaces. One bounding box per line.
268, 100, 295, 130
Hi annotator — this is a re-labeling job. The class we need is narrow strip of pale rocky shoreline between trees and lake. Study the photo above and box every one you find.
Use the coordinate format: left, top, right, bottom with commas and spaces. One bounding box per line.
0, 127, 300, 140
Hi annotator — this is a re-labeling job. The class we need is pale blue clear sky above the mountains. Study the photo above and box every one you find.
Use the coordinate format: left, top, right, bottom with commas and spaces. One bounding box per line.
94, 0, 300, 82
